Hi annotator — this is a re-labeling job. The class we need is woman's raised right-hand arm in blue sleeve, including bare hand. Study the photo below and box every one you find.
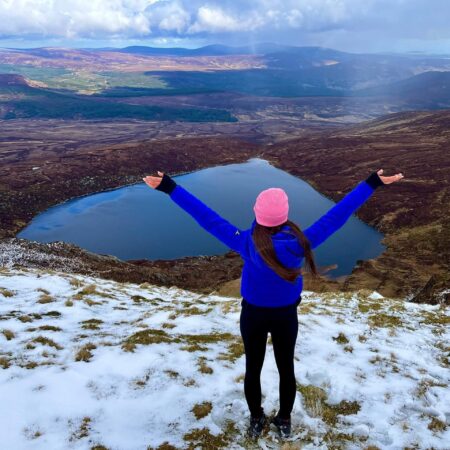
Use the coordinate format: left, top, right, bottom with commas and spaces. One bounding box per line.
304, 169, 403, 248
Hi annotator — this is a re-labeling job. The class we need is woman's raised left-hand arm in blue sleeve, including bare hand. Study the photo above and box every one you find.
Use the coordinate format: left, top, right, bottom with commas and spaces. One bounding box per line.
143, 172, 247, 256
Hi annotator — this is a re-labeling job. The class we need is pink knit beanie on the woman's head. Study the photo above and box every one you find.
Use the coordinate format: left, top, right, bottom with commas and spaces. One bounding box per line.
253, 188, 289, 227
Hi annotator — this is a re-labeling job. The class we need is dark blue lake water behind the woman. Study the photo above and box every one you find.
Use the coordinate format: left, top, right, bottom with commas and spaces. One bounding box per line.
18, 158, 385, 277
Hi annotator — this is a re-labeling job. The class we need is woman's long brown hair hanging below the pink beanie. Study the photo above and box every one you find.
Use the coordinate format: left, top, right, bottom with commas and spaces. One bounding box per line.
253, 220, 318, 282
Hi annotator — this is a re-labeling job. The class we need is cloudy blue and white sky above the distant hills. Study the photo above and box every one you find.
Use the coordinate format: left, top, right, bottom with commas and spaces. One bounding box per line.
0, 0, 450, 55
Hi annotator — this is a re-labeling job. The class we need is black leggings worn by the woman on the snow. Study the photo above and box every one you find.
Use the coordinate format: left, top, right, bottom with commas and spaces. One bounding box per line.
240, 297, 301, 418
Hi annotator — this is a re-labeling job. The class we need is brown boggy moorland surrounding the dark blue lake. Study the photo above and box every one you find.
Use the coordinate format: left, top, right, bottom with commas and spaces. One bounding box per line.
0, 111, 450, 302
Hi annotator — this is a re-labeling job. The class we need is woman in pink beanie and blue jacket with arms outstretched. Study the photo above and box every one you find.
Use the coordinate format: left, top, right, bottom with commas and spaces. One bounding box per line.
143, 169, 403, 438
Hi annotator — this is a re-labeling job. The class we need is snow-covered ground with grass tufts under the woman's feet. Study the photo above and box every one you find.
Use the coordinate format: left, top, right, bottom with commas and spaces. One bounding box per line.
0, 268, 450, 450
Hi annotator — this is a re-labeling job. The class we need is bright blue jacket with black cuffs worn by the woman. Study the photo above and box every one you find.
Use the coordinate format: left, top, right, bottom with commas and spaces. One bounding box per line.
157, 172, 383, 307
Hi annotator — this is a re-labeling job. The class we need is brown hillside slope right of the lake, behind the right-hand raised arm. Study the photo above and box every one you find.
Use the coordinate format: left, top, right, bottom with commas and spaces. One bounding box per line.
262, 110, 450, 301
